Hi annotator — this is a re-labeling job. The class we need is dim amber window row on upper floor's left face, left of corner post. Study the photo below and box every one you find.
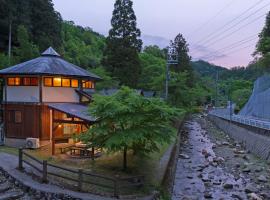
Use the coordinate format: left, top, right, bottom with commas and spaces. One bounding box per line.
7, 77, 38, 86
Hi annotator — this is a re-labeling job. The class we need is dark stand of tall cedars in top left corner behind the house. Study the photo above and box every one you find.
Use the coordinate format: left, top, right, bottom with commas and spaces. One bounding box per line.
0, 0, 62, 52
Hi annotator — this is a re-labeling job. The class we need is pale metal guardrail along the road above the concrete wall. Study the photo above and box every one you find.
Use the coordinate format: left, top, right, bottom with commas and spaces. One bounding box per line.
209, 110, 270, 130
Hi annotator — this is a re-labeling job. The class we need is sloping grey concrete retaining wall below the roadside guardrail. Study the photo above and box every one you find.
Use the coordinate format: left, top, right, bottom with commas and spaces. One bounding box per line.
208, 115, 270, 160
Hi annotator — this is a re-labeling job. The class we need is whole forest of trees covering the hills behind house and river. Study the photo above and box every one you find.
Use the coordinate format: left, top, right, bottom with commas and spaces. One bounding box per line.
0, 0, 270, 111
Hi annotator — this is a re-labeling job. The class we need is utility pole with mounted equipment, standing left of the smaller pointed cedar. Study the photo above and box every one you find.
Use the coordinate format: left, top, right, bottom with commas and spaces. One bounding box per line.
165, 47, 178, 100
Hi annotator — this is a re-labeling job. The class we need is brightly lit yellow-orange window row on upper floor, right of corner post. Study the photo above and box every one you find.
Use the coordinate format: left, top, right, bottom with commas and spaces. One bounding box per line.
44, 77, 79, 88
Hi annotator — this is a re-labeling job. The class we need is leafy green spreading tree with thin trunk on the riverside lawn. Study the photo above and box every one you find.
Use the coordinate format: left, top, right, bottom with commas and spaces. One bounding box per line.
79, 87, 182, 168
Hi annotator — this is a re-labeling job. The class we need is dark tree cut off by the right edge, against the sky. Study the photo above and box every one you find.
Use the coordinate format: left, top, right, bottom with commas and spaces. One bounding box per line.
254, 12, 270, 56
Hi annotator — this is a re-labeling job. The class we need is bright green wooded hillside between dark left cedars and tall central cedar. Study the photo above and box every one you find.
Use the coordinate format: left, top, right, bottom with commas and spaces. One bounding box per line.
62, 22, 105, 69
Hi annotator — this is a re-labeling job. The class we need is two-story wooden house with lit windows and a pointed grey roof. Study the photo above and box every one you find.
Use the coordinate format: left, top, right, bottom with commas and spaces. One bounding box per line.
0, 47, 100, 154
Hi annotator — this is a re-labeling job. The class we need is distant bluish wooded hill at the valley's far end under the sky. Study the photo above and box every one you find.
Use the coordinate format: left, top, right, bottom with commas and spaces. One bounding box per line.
191, 60, 229, 78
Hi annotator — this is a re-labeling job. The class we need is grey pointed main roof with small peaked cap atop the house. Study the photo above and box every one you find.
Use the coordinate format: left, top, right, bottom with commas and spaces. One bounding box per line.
0, 47, 101, 80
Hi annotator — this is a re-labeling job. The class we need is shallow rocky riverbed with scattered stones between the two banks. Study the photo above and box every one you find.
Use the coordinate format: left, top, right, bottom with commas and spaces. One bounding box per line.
172, 116, 270, 200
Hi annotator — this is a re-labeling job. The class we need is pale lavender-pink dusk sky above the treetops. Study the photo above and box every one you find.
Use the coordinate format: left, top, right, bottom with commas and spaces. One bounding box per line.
53, 0, 270, 67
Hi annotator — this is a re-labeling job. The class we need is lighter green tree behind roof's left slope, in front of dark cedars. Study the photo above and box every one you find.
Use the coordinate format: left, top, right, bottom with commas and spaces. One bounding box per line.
14, 25, 39, 62
